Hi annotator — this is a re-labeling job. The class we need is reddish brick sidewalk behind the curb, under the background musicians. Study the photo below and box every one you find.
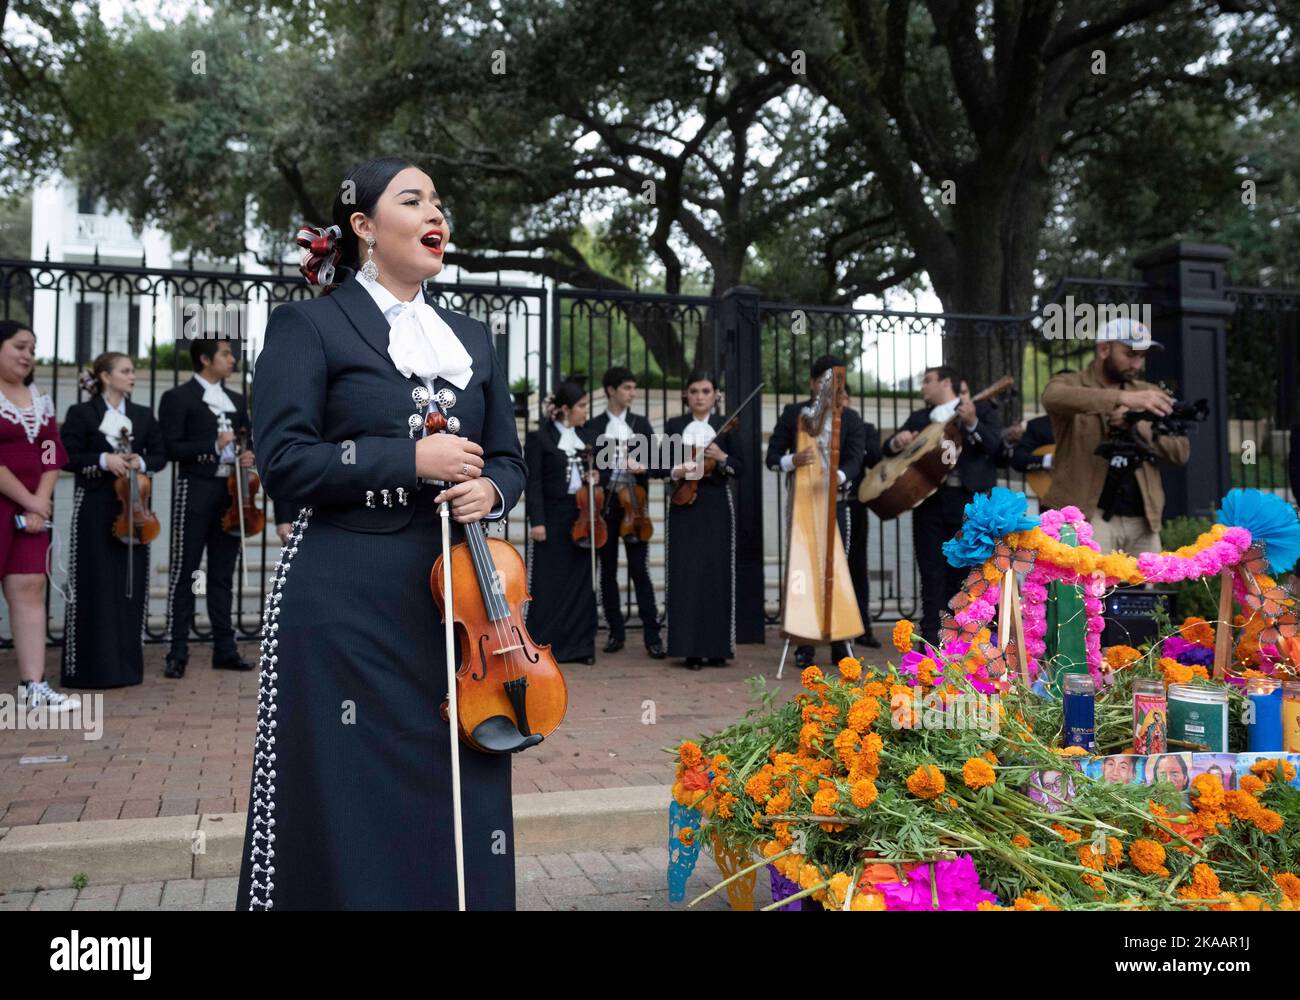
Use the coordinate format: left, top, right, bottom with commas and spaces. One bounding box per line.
0, 628, 887, 827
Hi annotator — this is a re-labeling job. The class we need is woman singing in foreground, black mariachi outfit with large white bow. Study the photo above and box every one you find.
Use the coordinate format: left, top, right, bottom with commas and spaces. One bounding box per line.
237, 157, 525, 910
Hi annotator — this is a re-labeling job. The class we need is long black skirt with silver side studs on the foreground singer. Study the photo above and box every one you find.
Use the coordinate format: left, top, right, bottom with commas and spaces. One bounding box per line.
235, 489, 515, 910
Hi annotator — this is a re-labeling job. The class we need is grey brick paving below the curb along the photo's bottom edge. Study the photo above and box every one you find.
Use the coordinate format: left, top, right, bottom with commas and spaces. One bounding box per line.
0, 848, 771, 913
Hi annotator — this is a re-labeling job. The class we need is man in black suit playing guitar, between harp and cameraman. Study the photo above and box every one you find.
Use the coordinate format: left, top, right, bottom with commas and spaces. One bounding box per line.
884, 364, 1002, 645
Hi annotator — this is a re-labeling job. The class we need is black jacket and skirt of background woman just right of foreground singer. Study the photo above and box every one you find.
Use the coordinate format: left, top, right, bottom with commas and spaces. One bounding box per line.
524, 421, 595, 663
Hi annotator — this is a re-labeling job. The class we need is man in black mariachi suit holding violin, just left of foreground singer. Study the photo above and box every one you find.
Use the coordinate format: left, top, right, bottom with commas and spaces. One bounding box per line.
159, 341, 256, 678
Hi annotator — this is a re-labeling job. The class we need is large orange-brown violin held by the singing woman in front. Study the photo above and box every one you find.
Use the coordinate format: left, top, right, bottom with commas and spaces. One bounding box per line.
425, 412, 568, 753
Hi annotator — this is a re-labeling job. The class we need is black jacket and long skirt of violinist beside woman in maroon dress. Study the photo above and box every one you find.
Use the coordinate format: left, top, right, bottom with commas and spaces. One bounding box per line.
60, 395, 166, 688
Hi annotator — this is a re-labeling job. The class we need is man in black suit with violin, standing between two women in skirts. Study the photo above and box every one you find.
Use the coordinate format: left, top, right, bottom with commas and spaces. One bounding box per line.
582, 367, 666, 659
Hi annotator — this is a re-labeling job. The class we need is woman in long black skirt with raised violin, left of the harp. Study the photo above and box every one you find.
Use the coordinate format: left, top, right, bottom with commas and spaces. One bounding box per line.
664, 372, 741, 670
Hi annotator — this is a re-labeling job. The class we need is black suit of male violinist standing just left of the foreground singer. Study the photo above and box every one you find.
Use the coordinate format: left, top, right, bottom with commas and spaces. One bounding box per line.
159, 378, 256, 663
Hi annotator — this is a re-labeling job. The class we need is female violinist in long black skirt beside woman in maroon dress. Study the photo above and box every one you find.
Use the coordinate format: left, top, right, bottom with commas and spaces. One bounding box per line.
62, 351, 166, 688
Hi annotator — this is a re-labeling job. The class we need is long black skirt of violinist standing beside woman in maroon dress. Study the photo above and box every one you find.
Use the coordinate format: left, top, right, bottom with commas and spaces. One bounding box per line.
61, 486, 150, 689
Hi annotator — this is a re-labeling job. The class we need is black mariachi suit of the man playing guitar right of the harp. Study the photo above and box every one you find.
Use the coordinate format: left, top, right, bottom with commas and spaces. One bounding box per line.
884, 401, 1002, 645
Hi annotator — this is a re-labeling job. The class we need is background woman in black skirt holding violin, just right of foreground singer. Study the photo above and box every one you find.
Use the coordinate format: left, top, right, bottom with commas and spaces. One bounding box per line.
524, 382, 595, 663
